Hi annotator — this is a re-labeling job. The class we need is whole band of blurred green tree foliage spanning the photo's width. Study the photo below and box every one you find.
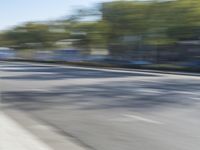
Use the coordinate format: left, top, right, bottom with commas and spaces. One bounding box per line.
0, 0, 200, 47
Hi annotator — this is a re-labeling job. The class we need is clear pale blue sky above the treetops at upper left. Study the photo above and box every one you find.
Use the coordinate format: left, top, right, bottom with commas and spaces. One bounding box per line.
0, 0, 112, 30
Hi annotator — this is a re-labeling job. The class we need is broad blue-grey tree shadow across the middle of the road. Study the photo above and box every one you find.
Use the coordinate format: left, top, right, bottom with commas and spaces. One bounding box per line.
2, 80, 200, 111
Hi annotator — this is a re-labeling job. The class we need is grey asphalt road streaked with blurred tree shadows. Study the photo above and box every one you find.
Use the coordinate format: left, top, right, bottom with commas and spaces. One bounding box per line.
0, 62, 200, 150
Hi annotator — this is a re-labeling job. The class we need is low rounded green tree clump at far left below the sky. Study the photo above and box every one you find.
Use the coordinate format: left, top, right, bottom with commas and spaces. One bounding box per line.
1, 23, 68, 49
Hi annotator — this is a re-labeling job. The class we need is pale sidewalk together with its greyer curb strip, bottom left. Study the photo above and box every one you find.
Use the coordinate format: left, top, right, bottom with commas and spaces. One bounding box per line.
0, 110, 86, 150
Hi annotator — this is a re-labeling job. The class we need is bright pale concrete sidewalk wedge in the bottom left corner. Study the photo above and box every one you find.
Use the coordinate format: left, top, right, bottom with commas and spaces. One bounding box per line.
0, 112, 52, 150
